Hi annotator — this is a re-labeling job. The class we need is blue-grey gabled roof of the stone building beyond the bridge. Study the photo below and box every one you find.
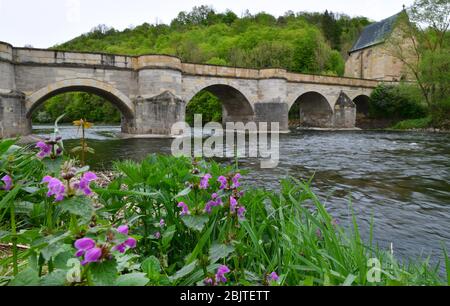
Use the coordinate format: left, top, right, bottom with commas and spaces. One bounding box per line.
350, 11, 404, 53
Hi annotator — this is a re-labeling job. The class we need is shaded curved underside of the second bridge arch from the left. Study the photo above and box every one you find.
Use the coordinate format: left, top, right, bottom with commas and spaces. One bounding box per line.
186, 84, 255, 122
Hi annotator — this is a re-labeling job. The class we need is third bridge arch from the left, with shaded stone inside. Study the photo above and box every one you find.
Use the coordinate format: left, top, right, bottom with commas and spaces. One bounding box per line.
289, 91, 333, 127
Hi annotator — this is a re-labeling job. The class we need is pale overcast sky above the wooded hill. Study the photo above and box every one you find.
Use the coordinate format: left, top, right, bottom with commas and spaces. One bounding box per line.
0, 0, 414, 48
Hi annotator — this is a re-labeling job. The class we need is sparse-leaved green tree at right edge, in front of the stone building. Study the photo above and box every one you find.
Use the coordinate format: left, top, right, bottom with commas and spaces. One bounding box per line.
386, 0, 450, 108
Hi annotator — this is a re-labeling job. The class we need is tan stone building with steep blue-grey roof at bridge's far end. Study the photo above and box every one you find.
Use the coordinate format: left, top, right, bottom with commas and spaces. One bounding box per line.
345, 11, 410, 81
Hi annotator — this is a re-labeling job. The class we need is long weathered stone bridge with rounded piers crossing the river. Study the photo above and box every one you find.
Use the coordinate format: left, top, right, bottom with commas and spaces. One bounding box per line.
0, 42, 378, 138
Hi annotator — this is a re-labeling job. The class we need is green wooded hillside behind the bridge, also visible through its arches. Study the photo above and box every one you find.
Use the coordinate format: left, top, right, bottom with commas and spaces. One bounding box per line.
33, 6, 370, 123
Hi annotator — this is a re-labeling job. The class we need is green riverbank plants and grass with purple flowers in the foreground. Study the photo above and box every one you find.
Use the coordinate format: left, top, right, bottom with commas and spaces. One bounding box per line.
0, 140, 449, 286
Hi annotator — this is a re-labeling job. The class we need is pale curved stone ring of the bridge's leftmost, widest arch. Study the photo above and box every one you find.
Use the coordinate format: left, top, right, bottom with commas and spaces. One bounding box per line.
26, 79, 135, 121
